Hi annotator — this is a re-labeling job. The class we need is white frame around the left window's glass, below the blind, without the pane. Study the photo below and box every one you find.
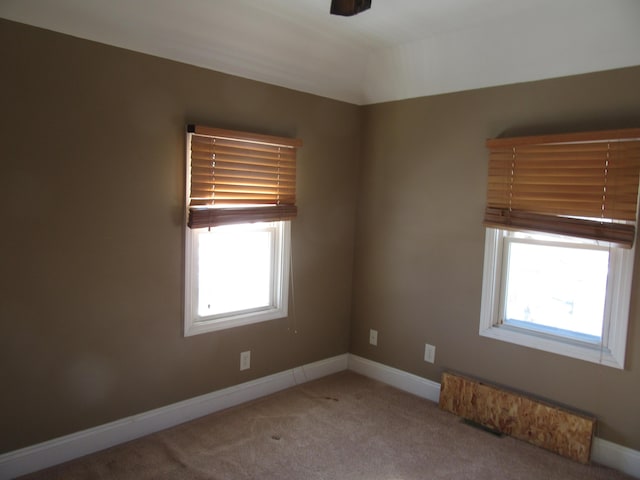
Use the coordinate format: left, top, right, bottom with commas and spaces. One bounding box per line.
184, 221, 291, 337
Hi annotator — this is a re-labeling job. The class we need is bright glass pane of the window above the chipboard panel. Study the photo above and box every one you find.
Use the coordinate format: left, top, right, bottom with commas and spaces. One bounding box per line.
505, 241, 609, 341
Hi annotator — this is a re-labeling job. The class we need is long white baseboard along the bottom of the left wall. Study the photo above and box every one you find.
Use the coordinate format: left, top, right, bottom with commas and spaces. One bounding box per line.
0, 353, 349, 480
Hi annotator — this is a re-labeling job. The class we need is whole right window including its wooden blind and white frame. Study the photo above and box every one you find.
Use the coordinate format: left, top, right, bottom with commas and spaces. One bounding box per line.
480, 130, 640, 368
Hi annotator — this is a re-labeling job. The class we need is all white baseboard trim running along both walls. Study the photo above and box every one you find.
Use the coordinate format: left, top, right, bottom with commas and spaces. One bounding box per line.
0, 354, 640, 480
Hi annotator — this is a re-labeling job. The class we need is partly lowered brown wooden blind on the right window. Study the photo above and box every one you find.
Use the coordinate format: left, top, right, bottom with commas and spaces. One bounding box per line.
484, 129, 640, 248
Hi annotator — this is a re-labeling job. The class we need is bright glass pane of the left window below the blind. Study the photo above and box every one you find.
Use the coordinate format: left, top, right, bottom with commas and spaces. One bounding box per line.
198, 225, 274, 317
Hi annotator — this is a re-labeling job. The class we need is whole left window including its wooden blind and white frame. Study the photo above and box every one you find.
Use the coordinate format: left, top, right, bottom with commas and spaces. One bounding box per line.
185, 126, 301, 335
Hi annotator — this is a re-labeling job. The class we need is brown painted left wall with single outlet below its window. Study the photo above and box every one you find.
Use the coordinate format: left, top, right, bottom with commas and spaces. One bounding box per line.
0, 21, 361, 452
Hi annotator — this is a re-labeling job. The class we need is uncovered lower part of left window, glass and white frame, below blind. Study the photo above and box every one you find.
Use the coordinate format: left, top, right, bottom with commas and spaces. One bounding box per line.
185, 221, 290, 335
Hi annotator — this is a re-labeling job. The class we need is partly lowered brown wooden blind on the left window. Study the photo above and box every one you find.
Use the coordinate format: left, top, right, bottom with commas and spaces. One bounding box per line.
187, 125, 302, 228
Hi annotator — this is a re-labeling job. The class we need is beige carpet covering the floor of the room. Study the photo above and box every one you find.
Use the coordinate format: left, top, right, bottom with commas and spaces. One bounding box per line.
23, 372, 631, 480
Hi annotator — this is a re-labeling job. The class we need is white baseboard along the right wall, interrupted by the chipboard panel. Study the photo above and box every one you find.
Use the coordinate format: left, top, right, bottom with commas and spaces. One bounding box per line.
349, 354, 640, 479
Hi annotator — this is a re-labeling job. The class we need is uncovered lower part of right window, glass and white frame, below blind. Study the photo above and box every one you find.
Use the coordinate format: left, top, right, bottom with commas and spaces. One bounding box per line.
480, 228, 633, 368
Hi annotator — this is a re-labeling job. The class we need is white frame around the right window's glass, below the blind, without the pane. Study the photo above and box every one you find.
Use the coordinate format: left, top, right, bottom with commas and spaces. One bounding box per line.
479, 228, 635, 369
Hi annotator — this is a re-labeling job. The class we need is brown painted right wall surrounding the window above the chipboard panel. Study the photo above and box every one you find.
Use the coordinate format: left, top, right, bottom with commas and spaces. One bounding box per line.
350, 67, 640, 449
